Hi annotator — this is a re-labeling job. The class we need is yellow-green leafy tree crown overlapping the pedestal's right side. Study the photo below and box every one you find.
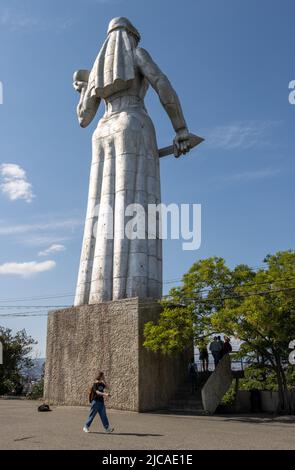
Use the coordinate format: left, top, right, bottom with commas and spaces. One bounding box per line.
144, 257, 255, 354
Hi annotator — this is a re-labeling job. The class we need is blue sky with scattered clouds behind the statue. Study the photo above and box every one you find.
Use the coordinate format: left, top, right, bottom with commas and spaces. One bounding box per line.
0, 0, 295, 355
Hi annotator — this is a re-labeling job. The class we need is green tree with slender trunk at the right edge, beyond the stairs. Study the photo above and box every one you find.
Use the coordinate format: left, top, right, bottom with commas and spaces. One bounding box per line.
211, 251, 295, 409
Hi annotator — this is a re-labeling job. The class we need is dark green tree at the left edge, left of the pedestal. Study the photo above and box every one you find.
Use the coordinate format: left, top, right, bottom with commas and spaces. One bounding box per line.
0, 326, 37, 395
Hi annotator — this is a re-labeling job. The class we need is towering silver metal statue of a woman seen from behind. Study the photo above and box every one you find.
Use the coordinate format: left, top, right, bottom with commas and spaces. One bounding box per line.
74, 18, 202, 306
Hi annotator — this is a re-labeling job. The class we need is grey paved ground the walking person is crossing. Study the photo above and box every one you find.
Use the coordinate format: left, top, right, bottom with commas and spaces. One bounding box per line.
0, 400, 295, 450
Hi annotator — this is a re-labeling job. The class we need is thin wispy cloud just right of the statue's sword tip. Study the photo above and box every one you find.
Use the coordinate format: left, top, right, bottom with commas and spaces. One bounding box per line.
204, 121, 279, 150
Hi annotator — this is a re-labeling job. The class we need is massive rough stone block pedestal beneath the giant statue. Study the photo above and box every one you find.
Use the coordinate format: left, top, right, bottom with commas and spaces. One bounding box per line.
44, 298, 187, 411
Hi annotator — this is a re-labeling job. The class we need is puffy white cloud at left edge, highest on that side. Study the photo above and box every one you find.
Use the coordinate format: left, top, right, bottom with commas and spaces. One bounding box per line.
0, 163, 34, 202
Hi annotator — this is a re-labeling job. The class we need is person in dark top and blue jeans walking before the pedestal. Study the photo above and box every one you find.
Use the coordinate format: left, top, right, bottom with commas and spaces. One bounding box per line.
83, 372, 114, 433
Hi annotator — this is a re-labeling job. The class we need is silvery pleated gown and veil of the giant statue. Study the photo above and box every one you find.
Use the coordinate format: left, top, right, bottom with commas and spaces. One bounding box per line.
75, 32, 162, 305
